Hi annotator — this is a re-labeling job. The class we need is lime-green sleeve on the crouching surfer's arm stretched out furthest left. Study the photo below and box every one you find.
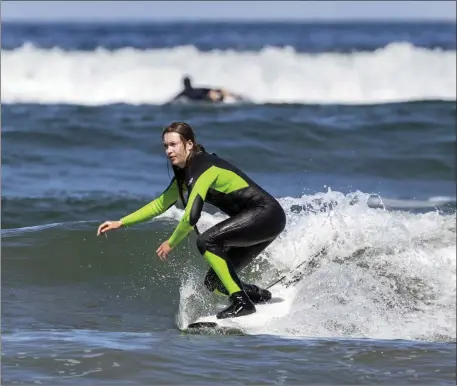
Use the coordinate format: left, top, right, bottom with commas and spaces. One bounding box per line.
121, 178, 179, 226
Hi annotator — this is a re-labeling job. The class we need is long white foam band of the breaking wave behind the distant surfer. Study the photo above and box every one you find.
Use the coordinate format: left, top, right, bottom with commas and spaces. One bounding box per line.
1, 43, 456, 105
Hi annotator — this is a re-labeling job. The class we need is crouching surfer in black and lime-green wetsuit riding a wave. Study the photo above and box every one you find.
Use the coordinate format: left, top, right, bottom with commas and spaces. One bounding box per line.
97, 122, 286, 319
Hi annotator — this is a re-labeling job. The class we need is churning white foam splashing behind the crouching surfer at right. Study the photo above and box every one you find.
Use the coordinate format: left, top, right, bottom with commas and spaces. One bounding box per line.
169, 190, 456, 340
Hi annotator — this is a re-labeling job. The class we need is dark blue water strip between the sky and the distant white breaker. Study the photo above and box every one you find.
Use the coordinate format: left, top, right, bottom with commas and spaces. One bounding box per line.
2, 22, 456, 53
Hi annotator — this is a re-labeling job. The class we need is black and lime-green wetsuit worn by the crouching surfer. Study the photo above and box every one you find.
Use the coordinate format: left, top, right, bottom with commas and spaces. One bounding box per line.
121, 151, 286, 295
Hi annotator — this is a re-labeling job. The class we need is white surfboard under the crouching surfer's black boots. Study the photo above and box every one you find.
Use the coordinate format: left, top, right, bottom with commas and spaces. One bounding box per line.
183, 297, 289, 335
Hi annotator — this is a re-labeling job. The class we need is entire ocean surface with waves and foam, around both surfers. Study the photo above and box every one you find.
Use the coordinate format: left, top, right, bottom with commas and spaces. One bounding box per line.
1, 23, 456, 385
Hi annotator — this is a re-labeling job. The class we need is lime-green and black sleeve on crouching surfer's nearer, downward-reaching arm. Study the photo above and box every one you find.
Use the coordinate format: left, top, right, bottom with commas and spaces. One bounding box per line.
168, 166, 220, 248
